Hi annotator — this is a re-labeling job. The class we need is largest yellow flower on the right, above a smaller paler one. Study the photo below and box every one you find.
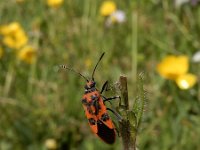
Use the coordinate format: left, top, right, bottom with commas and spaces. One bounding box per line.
157, 55, 189, 80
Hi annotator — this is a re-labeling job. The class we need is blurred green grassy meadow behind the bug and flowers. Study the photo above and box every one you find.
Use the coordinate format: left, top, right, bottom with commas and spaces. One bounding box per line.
0, 0, 200, 150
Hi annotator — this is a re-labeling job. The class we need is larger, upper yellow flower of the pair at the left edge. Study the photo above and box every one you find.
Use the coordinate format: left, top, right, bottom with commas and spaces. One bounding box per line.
0, 22, 28, 49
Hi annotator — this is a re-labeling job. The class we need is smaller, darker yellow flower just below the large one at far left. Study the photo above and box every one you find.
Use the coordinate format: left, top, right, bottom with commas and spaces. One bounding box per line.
18, 45, 37, 64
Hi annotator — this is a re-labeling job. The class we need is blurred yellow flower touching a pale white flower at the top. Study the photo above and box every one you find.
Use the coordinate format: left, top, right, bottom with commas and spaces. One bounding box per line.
100, 0, 117, 16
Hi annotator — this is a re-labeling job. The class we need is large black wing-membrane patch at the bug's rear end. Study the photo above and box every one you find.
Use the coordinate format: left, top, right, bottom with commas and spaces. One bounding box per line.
97, 120, 115, 144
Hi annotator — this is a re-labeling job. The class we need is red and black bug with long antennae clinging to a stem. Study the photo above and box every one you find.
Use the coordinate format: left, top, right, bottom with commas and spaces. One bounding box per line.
60, 53, 120, 144
